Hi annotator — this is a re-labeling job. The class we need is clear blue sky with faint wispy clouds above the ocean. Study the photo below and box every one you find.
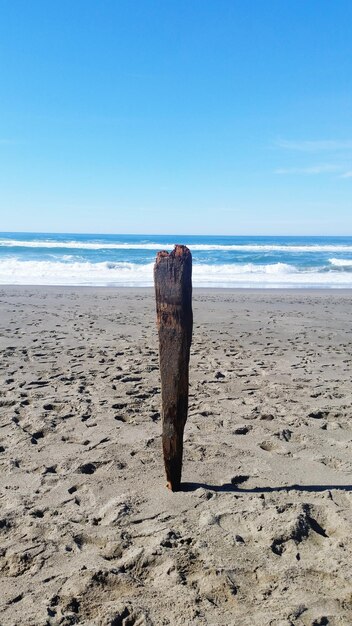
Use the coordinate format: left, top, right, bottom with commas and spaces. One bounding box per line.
0, 0, 352, 235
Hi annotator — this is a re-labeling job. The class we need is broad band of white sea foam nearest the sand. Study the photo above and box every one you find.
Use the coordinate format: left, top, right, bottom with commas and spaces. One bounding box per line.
0, 259, 352, 288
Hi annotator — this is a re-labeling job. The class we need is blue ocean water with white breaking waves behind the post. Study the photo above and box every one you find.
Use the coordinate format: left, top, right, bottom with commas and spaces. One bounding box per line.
0, 233, 352, 288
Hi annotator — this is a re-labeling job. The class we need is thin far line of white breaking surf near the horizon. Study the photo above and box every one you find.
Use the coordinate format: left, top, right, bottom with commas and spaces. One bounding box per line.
0, 239, 352, 253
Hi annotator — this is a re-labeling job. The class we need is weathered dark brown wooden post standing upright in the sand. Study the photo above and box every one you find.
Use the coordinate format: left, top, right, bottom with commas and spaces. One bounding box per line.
154, 245, 193, 491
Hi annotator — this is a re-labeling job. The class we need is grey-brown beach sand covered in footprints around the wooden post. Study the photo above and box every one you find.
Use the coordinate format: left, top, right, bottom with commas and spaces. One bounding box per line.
0, 287, 352, 626
